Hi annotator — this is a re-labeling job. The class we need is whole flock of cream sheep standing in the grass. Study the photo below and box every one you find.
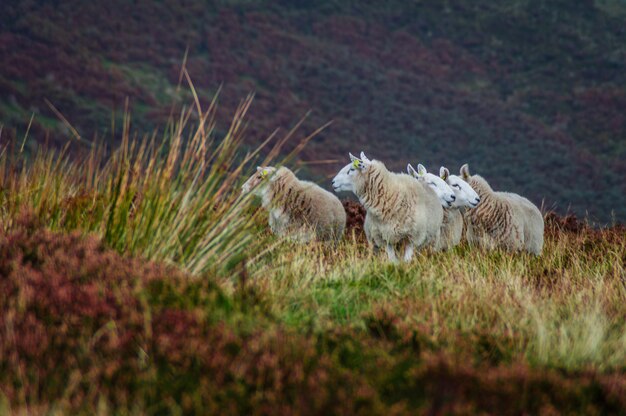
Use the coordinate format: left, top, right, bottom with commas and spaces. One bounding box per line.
242, 152, 544, 262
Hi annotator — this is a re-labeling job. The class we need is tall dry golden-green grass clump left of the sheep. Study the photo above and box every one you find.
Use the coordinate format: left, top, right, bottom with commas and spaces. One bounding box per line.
0, 89, 317, 275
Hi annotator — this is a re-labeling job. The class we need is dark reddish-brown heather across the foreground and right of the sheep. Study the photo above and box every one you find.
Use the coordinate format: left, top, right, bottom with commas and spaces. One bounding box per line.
0, 214, 626, 414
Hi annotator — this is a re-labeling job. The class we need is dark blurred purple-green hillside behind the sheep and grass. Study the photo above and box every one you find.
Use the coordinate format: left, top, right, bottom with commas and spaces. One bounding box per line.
0, 0, 626, 222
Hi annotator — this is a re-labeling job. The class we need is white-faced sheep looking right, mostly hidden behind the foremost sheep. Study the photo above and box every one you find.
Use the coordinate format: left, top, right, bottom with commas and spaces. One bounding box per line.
407, 164, 473, 250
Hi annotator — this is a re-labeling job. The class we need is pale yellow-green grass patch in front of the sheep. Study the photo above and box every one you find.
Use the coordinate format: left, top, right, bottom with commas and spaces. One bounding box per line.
255, 233, 626, 371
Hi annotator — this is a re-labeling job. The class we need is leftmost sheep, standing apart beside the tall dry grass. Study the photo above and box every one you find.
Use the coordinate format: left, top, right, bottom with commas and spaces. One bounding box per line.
241, 166, 346, 243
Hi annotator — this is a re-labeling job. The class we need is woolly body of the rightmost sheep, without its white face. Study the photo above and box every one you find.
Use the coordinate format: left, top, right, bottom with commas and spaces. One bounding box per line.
461, 164, 544, 256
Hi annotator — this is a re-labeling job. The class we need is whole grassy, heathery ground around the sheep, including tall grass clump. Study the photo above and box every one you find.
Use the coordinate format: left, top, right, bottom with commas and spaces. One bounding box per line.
0, 104, 626, 414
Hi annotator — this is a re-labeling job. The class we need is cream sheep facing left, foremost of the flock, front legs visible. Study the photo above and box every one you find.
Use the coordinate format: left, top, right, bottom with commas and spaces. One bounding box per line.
332, 152, 443, 263
